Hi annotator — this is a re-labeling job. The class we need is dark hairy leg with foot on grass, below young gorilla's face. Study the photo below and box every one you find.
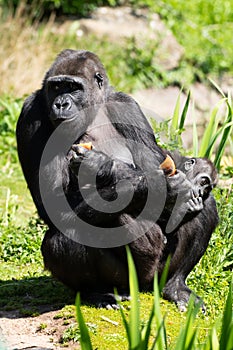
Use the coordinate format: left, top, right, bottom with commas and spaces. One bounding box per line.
160, 196, 218, 311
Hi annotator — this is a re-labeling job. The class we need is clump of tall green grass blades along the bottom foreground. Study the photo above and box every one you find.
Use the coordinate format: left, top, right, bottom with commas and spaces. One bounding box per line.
76, 247, 233, 350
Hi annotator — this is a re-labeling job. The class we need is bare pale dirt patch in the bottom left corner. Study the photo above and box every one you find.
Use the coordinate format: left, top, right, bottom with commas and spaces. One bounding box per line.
0, 311, 80, 350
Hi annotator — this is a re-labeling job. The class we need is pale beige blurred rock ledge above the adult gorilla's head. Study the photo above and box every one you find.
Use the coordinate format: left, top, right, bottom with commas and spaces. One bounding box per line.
77, 7, 183, 69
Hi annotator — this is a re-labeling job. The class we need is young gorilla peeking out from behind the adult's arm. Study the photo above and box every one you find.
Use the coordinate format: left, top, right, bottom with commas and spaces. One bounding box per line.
159, 152, 218, 311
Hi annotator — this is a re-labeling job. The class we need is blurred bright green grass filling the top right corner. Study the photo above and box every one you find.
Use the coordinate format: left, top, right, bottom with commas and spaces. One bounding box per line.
150, 0, 233, 84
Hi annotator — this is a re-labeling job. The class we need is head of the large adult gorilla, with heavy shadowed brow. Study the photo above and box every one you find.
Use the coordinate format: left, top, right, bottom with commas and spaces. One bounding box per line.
44, 50, 108, 125
